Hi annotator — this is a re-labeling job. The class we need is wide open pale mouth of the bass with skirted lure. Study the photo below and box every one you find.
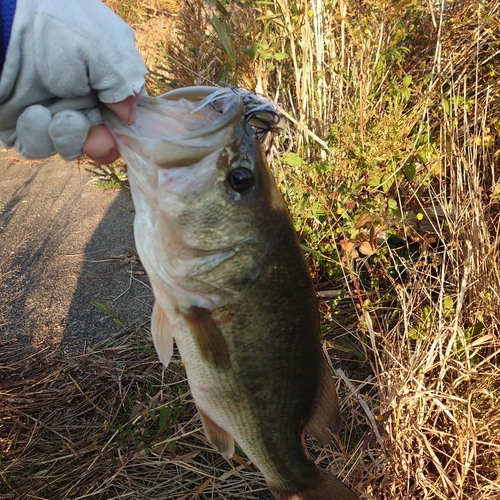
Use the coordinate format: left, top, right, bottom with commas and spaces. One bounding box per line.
101, 86, 284, 168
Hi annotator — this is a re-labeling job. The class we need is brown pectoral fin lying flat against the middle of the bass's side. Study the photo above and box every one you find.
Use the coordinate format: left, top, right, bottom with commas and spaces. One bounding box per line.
182, 306, 231, 370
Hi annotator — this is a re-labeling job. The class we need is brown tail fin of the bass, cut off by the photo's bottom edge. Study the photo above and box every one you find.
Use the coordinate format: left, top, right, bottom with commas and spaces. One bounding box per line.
269, 468, 359, 500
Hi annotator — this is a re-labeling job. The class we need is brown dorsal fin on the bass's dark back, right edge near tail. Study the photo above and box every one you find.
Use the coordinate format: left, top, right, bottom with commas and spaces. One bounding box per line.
306, 363, 340, 443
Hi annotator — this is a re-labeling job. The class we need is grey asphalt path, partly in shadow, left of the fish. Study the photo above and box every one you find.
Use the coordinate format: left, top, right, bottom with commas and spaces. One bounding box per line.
0, 150, 152, 356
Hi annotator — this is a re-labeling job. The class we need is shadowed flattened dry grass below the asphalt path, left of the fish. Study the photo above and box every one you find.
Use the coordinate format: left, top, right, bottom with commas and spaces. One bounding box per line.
0, 334, 270, 500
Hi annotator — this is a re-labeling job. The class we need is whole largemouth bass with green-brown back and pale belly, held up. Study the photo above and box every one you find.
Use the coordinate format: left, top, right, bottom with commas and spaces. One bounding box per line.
105, 87, 358, 500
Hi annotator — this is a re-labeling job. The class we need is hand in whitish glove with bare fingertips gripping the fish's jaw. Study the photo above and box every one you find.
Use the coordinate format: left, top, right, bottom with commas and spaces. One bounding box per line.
0, 0, 147, 161
